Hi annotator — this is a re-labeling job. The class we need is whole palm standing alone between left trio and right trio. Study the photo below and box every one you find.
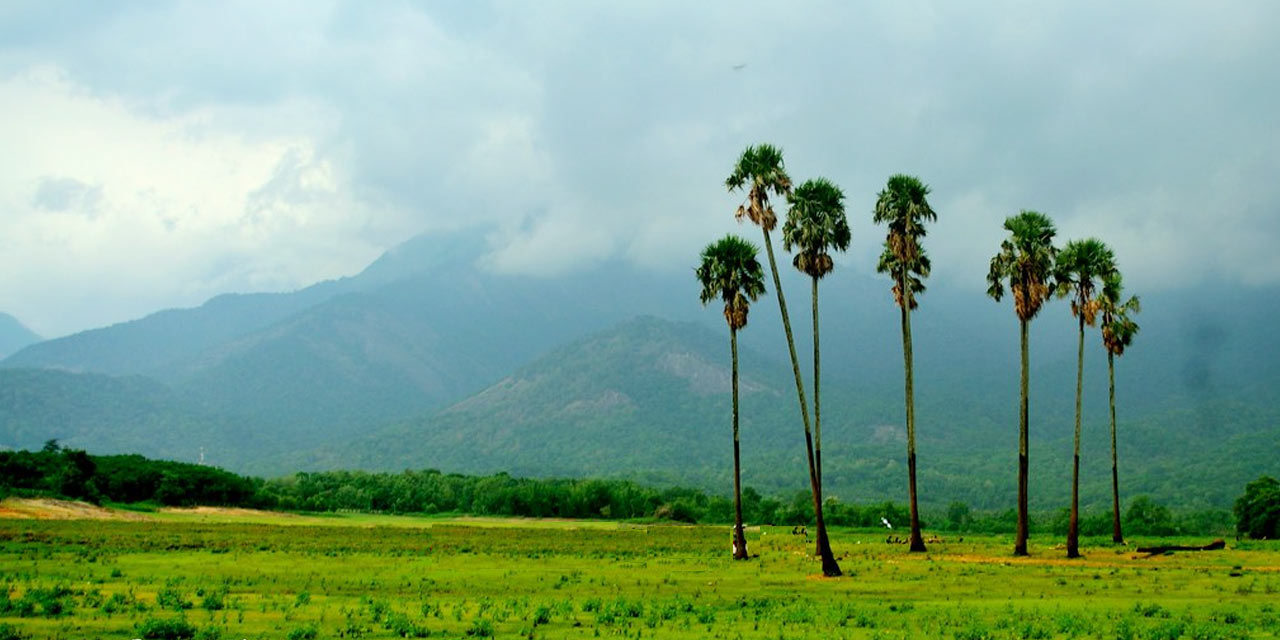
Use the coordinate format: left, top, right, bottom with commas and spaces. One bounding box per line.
874, 174, 938, 552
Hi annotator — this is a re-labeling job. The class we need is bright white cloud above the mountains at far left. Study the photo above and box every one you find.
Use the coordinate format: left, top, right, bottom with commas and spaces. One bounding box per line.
0, 67, 381, 335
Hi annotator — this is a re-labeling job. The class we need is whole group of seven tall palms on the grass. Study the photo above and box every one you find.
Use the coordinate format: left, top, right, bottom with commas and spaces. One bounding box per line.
696, 145, 1139, 576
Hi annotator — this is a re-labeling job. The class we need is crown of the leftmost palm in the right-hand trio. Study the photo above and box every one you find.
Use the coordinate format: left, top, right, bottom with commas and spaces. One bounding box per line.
987, 210, 1057, 321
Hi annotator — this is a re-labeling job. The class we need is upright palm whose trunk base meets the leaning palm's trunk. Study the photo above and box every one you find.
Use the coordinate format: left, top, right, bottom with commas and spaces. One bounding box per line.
782, 178, 852, 493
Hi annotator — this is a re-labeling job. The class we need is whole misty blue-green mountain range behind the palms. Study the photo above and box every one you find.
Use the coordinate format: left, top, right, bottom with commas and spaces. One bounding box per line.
0, 233, 1280, 508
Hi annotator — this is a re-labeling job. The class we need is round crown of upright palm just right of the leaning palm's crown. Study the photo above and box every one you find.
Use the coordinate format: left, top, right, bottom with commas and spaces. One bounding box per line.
782, 178, 852, 278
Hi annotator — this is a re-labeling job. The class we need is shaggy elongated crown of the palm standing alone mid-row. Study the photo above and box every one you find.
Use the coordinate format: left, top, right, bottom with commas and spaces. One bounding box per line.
873, 174, 938, 308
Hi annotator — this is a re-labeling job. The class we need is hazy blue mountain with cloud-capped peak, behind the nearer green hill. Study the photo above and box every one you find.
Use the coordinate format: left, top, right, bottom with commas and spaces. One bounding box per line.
0, 234, 695, 463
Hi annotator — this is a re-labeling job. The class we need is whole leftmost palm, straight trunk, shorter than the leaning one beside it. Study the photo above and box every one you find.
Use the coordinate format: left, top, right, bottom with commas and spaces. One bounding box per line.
695, 236, 764, 559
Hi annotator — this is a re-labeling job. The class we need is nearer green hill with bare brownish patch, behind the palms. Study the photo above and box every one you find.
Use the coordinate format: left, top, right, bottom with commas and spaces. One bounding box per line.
282, 311, 1280, 509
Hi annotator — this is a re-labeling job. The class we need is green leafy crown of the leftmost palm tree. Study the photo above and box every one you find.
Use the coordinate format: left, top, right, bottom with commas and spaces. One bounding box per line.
695, 234, 764, 330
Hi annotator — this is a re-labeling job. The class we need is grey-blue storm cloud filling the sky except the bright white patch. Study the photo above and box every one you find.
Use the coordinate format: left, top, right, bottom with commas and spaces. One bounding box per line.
0, 0, 1280, 335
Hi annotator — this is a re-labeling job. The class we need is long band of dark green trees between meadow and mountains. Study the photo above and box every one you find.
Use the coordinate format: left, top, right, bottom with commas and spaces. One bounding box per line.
0, 442, 1249, 535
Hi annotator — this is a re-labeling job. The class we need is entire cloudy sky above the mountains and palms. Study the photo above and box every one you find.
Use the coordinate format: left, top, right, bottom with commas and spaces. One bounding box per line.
0, 0, 1280, 337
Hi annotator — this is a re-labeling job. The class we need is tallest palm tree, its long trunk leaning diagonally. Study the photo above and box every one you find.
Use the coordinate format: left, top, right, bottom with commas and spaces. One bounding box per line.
724, 145, 841, 576
